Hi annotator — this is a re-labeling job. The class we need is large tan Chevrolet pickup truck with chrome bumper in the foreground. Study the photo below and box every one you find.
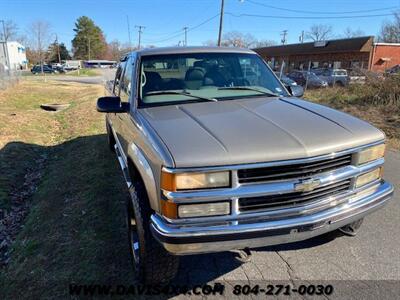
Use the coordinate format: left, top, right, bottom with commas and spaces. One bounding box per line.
97, 47, 393, 284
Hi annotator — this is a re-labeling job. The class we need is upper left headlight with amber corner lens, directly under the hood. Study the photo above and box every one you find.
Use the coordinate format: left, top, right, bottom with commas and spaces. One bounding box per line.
161, 171, 230, 191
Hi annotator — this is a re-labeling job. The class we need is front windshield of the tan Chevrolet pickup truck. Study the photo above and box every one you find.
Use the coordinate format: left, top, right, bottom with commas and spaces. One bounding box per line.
139, 53, 288, 107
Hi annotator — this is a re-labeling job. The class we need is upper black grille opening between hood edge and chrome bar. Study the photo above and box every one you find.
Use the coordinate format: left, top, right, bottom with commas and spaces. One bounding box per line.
238, 154, 351, 183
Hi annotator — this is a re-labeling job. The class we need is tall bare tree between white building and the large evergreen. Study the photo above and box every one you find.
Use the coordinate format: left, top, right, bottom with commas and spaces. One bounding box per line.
28, 20, 50, 71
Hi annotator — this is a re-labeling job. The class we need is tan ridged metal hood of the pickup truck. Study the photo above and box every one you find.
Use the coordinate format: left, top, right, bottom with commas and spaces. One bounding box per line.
139, 97, 384, 168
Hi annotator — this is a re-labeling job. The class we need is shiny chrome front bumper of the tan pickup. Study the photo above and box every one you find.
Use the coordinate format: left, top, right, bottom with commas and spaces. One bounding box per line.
151, 182, 393, 255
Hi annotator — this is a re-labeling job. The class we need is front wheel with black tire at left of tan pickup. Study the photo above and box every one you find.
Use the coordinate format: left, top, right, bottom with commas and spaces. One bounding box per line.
127, 179, 179, 285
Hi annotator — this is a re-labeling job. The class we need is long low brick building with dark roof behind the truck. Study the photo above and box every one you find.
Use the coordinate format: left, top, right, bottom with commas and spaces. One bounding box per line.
254, 36, 400, 72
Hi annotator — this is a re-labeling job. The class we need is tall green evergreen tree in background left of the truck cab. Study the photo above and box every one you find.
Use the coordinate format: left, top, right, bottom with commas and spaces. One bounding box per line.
72, 16, 107, 60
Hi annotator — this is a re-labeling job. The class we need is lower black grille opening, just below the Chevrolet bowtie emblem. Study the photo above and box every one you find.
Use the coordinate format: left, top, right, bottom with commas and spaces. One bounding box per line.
239, 179, 351, 212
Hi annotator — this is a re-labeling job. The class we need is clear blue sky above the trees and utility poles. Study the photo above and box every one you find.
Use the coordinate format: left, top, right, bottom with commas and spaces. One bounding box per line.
0, 0, 400, 48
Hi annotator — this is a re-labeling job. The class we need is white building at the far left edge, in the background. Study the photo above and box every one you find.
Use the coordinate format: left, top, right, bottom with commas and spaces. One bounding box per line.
0, 42, 28, 70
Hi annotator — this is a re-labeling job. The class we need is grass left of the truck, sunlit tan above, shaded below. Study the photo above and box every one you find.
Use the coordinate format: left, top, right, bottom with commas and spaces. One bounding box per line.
0, 81, 133, 299
